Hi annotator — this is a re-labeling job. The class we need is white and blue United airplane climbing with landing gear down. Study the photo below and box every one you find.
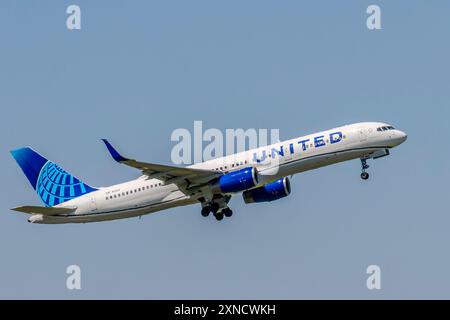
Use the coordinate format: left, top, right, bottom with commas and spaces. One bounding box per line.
11, 122, 407, 224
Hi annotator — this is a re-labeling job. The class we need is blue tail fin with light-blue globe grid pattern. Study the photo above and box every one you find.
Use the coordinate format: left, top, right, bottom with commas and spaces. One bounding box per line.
11, 147, 97, 207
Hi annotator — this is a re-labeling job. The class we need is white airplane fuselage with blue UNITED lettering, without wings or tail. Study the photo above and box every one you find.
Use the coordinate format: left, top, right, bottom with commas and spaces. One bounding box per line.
30, 122, 406, 223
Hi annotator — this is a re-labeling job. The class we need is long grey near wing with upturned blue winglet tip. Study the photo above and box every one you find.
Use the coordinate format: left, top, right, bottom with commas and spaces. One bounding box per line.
102, 139, 223, 189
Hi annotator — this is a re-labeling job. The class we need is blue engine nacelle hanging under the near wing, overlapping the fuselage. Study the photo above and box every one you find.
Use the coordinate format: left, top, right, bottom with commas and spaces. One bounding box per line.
213, 167, 258, 193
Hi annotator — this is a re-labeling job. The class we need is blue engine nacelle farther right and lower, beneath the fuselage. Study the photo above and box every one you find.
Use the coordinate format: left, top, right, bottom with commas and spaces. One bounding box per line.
242, 177, 291, 203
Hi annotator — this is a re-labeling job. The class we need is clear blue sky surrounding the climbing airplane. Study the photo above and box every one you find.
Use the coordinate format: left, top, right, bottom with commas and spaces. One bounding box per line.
0, 0, 450, 299
